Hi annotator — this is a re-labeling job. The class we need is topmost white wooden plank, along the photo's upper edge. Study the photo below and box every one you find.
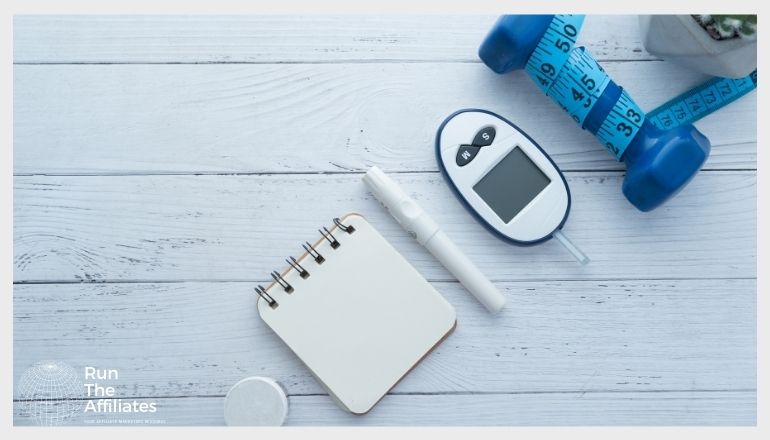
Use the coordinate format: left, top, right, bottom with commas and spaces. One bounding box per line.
13, 14, 654, 63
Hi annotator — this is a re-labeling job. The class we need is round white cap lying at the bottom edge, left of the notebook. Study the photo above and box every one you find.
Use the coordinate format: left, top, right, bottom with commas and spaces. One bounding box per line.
225, 376, 289, 426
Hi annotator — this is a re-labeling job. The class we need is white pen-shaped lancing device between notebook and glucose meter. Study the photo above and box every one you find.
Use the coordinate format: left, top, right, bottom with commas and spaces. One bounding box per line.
363, 166, 505, 313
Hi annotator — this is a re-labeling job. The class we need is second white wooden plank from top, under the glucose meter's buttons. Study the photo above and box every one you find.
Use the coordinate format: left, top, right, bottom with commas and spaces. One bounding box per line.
14, 62, 757, 174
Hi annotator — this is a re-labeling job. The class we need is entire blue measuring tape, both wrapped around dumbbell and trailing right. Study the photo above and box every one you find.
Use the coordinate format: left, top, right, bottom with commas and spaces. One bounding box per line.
525, 15, 757, 160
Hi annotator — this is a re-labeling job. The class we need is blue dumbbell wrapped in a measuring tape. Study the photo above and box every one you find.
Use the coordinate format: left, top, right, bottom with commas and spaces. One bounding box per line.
479, 15, 711, 211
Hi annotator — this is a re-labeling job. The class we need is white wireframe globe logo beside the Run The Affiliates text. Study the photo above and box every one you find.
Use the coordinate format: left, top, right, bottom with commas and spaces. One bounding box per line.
18, 361, 83, 426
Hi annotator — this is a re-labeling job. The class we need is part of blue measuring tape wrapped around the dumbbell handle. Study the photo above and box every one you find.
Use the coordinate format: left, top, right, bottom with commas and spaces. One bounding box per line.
525, 15, 645, 160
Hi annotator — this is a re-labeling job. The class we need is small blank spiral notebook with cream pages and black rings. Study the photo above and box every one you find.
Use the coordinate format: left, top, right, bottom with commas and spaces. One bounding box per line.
256, 214, 456, 414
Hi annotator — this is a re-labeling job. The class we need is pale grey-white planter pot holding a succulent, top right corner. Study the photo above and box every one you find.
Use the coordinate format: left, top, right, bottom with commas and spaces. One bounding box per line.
639, 15, 757, 78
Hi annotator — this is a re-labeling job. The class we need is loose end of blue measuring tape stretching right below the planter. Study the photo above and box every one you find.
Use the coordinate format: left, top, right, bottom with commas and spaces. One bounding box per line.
647, 70, 757, 128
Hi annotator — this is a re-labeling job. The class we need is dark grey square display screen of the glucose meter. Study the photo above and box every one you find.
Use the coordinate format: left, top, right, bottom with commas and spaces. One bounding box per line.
473, 147, 551, 223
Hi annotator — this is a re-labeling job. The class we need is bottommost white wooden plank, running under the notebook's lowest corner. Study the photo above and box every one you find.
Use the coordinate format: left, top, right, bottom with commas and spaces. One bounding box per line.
13, 391, 757, 426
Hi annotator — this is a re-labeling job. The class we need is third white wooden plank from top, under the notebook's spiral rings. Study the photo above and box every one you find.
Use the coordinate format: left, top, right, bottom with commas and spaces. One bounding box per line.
14, 171, 757, 282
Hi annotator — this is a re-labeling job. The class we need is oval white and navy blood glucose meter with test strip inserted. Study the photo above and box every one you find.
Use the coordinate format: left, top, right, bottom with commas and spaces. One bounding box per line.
436, 109, 588, 264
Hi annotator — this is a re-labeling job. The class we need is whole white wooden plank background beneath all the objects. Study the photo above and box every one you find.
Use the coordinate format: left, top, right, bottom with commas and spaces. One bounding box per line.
13, 16, 757, 425
